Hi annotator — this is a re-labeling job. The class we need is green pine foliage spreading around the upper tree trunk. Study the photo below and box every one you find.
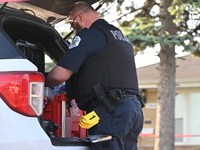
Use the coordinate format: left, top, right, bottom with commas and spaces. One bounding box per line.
103, 0, 200, 54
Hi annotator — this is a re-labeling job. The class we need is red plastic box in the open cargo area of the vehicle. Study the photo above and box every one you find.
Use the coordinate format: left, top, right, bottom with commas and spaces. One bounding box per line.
43, 93, 87, 138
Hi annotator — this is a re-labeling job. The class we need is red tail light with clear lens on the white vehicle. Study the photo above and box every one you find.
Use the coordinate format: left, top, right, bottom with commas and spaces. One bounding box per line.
0, 72, 44, 116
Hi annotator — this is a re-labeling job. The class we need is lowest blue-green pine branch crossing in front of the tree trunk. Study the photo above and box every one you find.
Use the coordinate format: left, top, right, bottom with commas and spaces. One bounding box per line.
127, 26, 195, 52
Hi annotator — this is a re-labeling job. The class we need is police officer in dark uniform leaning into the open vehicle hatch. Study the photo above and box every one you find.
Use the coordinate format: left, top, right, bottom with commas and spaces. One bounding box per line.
46, 2, 143, 150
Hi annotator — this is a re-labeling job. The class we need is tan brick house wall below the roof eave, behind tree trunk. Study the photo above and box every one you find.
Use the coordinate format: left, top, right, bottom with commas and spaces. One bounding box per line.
138, 88, 200, 150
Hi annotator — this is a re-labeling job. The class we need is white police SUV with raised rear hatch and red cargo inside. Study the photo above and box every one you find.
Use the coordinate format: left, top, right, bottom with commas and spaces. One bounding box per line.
0, 0, 98, 150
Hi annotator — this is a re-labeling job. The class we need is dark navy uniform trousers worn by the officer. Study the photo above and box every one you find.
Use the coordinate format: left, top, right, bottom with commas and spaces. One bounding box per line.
89, 97, 144, 150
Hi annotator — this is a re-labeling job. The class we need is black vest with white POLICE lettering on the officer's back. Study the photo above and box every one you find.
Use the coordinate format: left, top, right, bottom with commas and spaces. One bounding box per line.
67, 24, 138, 108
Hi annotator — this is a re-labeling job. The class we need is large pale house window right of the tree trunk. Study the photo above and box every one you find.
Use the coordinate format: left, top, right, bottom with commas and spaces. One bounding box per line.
175, 93, 200, 145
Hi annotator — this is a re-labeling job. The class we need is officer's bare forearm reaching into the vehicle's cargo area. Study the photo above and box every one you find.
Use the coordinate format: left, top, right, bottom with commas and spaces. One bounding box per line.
45, 66, 73, 88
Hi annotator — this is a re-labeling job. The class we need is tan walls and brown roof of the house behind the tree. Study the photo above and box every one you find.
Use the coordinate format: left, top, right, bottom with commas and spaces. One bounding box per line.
137, 55, 200, 150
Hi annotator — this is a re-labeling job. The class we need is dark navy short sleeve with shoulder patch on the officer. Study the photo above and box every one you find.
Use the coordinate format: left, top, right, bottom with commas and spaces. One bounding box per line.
58, 19, 107, 73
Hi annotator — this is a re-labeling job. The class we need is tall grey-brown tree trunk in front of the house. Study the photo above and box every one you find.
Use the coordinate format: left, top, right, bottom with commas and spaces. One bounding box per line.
154, 0, 176, 150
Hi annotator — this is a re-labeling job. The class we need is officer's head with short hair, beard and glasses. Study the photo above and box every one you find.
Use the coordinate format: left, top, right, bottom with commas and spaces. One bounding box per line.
69, 2, 100, 34
